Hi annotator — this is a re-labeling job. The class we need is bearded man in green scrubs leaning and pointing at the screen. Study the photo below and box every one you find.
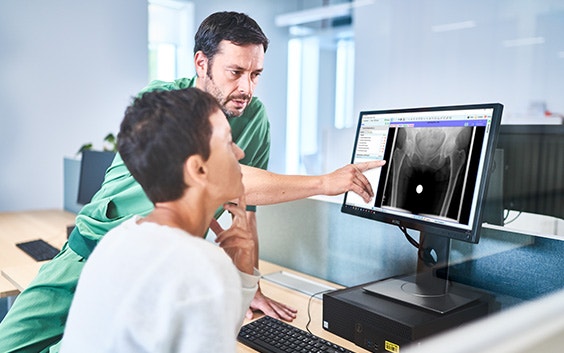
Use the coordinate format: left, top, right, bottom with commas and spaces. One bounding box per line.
0, 12, 380, 353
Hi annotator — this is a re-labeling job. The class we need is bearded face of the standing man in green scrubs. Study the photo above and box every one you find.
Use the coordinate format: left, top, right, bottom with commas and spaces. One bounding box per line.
196, 41, 264, 117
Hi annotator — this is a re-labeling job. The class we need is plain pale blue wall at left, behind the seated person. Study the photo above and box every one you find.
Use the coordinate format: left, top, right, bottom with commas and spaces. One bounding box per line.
0, 0, 148, 211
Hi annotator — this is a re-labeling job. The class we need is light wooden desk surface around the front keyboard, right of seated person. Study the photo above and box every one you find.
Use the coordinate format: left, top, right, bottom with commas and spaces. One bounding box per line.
237, 261, 368, 353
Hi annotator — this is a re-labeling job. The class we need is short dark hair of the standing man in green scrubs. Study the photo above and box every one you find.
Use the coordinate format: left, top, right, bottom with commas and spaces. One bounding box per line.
194, 11, 268, 60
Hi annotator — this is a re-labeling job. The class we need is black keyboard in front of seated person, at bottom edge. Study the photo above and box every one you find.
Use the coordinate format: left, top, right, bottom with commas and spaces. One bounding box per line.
238, 316, 353, 353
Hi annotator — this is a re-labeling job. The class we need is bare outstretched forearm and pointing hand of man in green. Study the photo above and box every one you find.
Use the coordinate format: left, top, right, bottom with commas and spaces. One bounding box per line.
241, 161, 386, 205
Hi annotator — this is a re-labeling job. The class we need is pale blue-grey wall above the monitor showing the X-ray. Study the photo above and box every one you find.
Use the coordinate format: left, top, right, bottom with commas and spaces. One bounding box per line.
354, 0, 564, 114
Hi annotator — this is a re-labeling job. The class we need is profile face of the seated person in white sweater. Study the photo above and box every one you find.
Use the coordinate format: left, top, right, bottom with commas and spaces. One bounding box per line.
206, 110, 245, 199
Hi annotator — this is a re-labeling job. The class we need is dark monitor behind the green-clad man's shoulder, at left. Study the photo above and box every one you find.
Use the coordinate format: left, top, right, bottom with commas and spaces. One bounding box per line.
77, 150, 116, 205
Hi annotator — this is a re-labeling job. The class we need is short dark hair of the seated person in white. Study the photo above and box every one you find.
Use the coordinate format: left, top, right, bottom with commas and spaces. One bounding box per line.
118, 88, 221, 203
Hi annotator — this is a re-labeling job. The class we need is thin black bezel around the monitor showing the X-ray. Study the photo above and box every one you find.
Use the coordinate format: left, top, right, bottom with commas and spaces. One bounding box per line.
341, 103, 503, 243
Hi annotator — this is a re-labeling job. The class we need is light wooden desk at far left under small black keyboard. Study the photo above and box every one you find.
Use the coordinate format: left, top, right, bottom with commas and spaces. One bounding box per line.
0, 210, 75, 297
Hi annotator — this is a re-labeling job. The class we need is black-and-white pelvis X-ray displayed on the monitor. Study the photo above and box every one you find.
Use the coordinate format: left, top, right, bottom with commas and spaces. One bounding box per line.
377, 126, 484, 223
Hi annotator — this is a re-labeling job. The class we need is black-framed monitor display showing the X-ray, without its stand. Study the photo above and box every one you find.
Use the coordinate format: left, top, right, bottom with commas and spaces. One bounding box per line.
341, 103, 503, 243
